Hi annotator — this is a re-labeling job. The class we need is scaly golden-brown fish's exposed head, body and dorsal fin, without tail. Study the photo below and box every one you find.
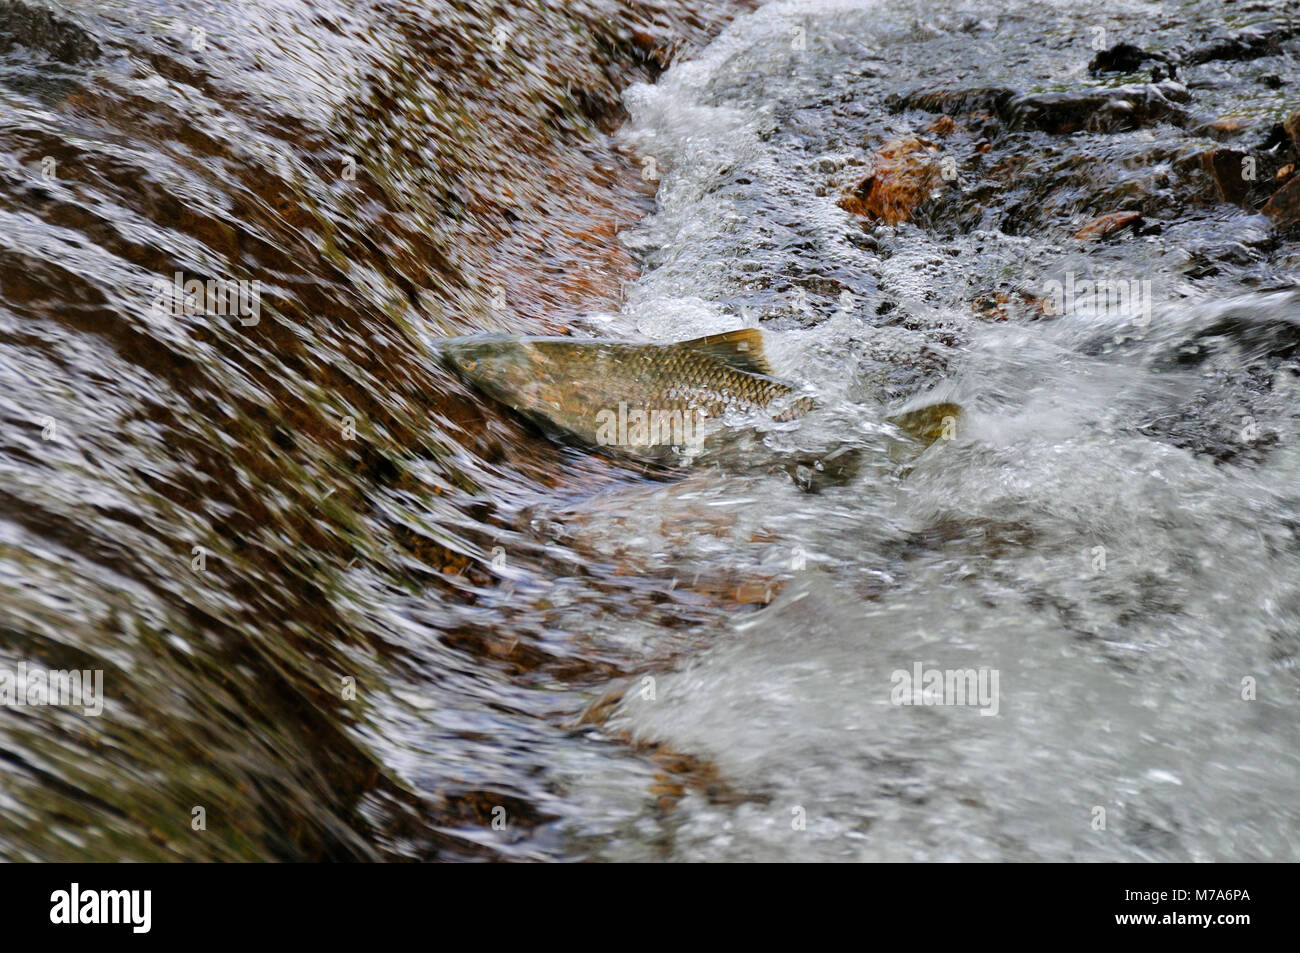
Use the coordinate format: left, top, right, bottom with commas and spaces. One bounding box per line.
441, 329, 813, 456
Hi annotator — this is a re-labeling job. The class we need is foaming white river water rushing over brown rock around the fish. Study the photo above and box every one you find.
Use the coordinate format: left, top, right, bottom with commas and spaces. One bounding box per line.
0, 0, 1300, 861
